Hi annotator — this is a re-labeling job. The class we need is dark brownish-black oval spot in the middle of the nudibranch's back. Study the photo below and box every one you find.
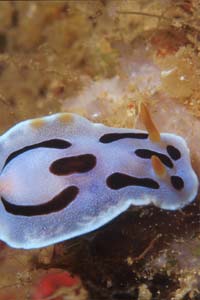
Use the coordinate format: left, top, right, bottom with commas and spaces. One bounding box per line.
49, 154, 96, 175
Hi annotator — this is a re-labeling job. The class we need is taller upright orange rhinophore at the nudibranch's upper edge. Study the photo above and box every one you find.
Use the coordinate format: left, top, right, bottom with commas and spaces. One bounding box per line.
141, 103, 161, 143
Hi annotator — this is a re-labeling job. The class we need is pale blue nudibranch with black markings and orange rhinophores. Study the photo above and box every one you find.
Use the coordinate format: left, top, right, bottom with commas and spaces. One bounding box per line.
0, 105, 198, 249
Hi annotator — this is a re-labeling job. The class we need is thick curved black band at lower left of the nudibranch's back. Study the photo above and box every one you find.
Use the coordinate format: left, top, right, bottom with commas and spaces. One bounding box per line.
1, 186, 79, 217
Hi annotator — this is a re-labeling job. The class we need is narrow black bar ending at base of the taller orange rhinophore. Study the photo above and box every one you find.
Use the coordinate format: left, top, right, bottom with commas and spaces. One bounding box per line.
99, 132, 148, 144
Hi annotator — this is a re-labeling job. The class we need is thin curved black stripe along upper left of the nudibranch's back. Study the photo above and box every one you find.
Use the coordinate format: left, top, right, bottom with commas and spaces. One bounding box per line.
3, 139, 72, 168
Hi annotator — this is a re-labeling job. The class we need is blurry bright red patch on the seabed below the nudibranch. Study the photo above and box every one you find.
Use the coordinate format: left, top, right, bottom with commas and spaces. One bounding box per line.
32, 272, 80, 300
